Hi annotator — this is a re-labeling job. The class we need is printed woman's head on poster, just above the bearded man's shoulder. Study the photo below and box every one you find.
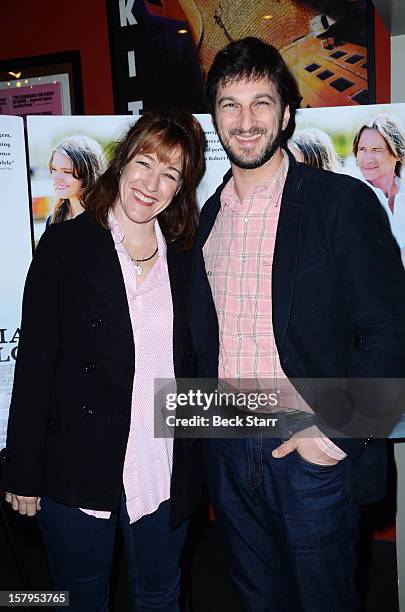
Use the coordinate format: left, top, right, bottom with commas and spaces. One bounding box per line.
288, 128, 341, 172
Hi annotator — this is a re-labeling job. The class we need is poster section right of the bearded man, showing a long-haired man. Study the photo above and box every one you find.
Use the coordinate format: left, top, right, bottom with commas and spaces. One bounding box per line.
290, 104, 405, 265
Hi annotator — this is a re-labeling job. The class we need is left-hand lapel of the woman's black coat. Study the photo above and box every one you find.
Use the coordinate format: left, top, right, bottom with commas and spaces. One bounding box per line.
80, 213, 132, 335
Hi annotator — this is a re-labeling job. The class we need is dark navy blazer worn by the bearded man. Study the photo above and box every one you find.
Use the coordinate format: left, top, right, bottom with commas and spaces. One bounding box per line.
190, 152, 405, 503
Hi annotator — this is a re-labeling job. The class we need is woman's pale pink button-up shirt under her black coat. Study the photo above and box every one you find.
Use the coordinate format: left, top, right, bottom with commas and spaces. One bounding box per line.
82, 212, 174, 523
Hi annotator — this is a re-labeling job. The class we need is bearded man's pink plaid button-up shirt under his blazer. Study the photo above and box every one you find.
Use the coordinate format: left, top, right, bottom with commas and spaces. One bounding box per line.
203, 153, 346, 459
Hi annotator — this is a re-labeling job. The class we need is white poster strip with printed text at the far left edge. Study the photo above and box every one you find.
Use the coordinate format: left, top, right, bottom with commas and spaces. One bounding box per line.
0, 116, 32, 449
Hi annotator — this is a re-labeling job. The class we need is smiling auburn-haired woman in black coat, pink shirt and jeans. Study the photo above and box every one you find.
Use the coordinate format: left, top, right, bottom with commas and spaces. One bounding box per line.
2, 112, 205, 612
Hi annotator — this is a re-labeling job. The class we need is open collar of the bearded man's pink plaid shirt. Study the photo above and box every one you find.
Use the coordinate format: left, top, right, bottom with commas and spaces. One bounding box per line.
220, 149, 289, 209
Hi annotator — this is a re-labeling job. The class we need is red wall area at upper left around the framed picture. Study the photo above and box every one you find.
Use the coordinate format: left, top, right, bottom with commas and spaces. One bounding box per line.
0, 0, 114, 115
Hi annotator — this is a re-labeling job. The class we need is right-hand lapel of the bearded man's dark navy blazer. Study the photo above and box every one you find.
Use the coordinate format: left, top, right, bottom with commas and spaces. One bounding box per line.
272, 151, 305, 355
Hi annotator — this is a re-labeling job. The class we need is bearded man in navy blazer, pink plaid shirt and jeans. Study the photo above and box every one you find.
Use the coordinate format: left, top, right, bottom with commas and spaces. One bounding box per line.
190, 38, 405, 612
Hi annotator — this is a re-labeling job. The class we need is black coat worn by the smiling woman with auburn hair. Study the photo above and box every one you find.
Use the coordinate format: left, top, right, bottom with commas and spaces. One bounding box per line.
1, 213, 202, 524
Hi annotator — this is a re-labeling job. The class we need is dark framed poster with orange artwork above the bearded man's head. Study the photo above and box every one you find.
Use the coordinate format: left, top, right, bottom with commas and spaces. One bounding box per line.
107, 0, 375, 114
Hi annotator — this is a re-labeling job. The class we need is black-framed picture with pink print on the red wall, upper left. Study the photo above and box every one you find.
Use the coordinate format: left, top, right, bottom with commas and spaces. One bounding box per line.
0, 51, 83, 117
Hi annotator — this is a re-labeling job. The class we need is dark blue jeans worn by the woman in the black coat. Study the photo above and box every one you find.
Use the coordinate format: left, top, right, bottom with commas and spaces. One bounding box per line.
38, 497, 187, 612
